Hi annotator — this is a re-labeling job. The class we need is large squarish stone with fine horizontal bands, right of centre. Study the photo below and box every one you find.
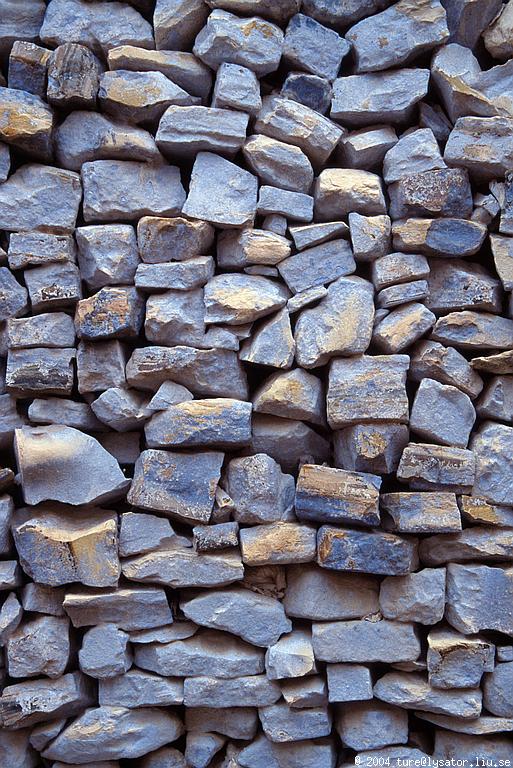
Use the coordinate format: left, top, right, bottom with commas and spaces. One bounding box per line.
327, 355, 410, 429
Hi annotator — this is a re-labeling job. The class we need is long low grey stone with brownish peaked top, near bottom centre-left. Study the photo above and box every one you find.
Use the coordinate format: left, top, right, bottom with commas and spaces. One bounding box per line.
135, 629, 264, 678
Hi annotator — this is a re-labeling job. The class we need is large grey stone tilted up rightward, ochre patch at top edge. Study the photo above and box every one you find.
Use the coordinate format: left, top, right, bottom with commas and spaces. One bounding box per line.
346, 0, 449, 72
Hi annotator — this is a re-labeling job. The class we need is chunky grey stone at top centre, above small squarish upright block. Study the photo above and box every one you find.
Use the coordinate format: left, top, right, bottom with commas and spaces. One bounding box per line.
193, 9, 283, 77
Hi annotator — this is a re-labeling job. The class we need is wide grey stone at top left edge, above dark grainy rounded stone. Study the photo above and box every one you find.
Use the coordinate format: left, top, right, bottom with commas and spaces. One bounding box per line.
40, 0, 154, 56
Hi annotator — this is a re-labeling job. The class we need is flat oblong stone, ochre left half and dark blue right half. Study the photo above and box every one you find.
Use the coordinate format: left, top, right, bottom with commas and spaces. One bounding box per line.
392, 218, 487, 258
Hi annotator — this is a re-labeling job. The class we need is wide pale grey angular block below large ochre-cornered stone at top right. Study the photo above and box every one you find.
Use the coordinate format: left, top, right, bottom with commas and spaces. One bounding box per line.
331, 69, 430, 127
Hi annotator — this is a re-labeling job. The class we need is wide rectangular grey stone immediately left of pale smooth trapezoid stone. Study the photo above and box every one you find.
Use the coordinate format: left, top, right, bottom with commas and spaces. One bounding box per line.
82, 160, 185, 222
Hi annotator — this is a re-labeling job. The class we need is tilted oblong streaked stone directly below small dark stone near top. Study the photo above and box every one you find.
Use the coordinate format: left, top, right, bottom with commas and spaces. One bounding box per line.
254, 96, 343, 164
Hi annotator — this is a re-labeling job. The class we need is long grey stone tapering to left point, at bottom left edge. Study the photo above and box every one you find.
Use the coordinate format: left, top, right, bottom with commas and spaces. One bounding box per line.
43, 707, 183, 763
